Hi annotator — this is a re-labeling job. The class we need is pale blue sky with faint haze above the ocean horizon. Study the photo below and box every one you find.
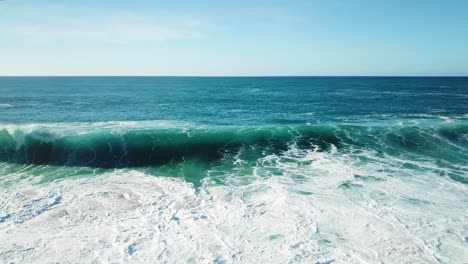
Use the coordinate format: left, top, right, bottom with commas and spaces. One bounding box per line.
0, 0, 468, 76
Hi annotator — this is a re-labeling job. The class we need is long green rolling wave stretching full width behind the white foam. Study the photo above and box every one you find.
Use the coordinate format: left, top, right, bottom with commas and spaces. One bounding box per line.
0, 124, 468, 173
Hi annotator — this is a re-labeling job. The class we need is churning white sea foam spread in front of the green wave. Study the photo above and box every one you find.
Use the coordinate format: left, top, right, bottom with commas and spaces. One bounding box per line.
0, 145, 468, 263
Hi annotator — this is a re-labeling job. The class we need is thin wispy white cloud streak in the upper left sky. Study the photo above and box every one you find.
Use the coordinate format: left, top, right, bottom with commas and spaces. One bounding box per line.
0, 15, 204, 43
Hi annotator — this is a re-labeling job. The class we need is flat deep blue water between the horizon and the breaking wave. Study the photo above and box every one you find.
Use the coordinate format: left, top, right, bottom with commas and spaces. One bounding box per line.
0, 77, 468, 126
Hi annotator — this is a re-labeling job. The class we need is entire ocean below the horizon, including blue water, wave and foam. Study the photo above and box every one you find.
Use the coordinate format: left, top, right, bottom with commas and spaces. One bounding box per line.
0, 77, 468, 263
